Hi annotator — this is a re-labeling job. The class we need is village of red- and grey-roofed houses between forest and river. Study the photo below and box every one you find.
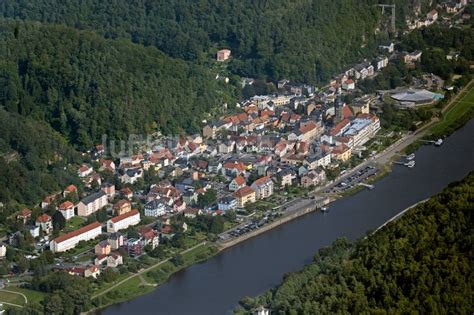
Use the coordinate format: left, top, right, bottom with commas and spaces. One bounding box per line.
0, 1, 466, 292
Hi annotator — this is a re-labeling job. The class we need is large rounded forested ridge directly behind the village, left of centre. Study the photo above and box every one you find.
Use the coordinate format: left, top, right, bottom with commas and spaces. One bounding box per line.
0, 20, 231, 148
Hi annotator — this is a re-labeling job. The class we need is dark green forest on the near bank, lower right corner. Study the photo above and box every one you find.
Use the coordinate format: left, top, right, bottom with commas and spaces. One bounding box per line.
237, 172, 474, 314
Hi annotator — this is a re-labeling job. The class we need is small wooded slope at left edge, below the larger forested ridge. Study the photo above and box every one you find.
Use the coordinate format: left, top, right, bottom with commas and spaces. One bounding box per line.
0, 109, 81, 207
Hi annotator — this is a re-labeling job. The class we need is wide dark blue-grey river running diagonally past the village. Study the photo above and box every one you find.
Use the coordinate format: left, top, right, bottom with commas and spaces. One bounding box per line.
100, 120, 474, 315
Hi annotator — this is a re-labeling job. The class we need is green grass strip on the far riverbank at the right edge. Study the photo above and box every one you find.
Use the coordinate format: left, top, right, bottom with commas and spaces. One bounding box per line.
431, 86, 474, 136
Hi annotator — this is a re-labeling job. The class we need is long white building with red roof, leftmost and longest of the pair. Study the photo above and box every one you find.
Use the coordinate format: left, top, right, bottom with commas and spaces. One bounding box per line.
49, 222, 102, 253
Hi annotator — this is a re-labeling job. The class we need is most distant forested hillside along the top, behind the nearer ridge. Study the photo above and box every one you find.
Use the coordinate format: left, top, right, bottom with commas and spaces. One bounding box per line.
0, 0, 428, 83
